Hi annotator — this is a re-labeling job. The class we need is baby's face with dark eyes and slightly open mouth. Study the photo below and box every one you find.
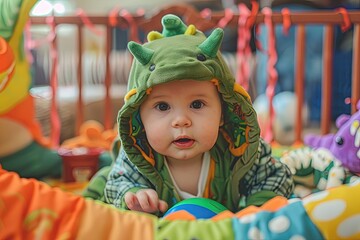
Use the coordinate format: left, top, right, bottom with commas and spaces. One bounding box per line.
140, 80, 221, 161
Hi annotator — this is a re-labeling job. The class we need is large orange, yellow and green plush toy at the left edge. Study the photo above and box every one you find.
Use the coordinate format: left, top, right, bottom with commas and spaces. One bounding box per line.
0, 0, 62, 178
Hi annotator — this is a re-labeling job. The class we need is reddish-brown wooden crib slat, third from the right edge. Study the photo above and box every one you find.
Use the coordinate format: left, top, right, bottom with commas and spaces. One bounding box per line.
295, 24, 306, 143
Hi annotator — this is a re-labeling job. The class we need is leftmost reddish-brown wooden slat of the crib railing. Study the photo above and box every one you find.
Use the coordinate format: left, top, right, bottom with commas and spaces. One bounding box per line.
75, 25, 84, 135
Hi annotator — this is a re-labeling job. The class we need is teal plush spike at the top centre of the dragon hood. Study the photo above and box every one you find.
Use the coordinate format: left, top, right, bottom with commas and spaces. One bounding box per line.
161, 14, 187, 37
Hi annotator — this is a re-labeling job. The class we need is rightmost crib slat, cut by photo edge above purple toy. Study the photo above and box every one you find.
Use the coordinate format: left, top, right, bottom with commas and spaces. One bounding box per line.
351, 24, 360, 113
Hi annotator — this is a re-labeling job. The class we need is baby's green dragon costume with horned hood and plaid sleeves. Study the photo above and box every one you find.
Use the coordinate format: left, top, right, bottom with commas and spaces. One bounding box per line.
100, 14, 293, 214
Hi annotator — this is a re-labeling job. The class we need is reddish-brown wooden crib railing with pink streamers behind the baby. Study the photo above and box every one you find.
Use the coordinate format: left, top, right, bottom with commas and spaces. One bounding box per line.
30, 5, 360, 146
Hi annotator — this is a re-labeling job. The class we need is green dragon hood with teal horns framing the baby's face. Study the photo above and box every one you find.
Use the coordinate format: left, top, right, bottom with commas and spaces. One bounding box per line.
118, 14, 260, 188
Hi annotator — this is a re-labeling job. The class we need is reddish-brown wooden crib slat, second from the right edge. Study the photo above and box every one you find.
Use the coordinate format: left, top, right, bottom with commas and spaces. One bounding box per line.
321, 24, 334, 134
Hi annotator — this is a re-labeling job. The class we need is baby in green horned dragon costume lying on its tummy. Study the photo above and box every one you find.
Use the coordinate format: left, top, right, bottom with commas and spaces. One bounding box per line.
104, 14, 293, 215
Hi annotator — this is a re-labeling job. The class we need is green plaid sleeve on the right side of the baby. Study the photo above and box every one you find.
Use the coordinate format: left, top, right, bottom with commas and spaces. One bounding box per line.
240, 140, 294, 206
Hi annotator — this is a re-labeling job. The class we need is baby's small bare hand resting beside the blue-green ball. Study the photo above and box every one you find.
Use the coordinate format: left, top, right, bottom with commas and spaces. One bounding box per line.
124, 189, 168, 213
